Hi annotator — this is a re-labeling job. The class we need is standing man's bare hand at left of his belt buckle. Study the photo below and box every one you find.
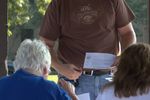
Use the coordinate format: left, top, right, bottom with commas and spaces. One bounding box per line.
58, 64, 82, 80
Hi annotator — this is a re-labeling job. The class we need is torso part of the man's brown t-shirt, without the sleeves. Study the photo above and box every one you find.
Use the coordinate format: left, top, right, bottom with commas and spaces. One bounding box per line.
58, 0, 118, 66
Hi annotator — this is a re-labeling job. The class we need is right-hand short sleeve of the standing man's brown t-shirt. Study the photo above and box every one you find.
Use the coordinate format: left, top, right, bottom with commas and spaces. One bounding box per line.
114, 0, 135, 28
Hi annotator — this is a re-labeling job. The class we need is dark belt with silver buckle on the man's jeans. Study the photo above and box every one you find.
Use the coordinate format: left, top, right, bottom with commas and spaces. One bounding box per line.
82, 69, 110, 76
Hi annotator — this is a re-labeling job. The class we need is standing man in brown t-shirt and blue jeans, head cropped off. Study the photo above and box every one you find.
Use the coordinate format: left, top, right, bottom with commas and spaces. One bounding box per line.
40, 0, 136, 100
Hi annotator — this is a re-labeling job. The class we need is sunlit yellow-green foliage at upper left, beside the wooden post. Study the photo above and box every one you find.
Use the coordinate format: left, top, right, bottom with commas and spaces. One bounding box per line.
8, 0, 51, 36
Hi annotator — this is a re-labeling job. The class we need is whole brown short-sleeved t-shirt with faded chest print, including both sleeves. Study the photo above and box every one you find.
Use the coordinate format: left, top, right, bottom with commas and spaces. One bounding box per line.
40, 0, 134, 67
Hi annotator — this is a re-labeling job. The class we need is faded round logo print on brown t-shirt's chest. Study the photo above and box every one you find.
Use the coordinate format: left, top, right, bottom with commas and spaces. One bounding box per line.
73, 5, 98, 24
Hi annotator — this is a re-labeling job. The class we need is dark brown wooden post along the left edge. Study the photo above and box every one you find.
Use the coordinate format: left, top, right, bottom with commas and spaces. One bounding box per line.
0, 0, 8, 77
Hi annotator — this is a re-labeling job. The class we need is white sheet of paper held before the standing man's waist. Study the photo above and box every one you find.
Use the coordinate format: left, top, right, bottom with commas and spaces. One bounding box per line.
84, 52, 116, 69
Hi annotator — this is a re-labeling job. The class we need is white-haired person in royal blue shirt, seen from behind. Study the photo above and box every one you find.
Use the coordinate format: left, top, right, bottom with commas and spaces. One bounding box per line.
0, 39, 77, 100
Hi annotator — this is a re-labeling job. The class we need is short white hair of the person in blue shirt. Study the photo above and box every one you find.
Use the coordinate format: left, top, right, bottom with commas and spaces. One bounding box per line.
14, 39, 51, 71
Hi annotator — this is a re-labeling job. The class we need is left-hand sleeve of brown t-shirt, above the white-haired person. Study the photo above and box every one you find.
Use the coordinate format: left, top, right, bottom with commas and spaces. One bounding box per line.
39, 0, 60, 40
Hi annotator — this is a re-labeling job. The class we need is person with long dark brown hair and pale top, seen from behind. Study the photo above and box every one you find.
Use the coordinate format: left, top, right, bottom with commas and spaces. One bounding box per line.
96, 44, 150, 100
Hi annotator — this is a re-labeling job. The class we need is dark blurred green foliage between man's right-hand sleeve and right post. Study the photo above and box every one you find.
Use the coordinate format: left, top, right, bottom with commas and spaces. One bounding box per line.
126, 0, 148, 37
